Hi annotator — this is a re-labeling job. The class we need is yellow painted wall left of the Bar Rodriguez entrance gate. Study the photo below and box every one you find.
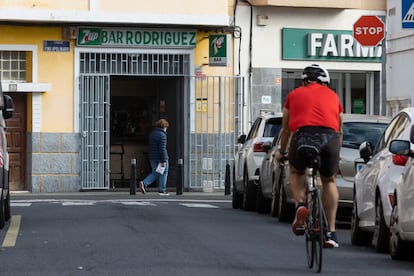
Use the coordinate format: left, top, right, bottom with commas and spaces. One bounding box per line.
0, 26, 74, 132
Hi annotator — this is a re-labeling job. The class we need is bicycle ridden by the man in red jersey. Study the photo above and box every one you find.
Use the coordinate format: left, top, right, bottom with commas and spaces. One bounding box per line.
298, 145, 328, 272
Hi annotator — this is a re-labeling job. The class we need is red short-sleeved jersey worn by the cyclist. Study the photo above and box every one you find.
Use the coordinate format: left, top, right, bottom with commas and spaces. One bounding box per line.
284, 83, 343, 132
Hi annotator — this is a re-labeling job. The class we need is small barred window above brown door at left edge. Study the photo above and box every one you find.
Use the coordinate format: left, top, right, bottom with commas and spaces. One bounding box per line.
0, 51, 26, 82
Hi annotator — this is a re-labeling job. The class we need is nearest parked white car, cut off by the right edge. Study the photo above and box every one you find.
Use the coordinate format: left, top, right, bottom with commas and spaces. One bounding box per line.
390, 139, 414, 260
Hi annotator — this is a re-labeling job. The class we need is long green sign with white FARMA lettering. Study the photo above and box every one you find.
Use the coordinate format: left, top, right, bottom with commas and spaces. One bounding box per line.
282, 28, 382, 62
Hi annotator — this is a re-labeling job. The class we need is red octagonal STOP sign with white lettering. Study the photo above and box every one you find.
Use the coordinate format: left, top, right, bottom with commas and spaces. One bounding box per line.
353, 15, 385, 46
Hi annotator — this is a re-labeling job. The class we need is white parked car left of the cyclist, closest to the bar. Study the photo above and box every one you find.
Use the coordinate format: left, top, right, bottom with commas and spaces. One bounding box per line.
232, 112, 282, 211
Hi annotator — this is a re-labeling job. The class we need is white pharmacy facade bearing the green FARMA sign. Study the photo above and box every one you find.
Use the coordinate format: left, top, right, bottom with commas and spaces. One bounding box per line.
234, 0, 386, 131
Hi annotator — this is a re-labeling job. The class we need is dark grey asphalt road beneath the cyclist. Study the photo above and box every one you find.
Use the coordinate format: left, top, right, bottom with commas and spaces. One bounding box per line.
0, 192, 414, 276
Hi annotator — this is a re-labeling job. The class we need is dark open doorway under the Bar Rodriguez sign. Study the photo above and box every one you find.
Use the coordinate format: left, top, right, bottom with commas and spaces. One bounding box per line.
110, 76, 184, 187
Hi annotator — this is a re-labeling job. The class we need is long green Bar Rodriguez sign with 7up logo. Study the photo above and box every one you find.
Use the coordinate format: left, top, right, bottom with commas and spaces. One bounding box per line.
78, 28, 197, 48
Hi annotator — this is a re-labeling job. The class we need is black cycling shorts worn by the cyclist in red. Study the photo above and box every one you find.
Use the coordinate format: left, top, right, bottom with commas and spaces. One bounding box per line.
289, 126, 340, 177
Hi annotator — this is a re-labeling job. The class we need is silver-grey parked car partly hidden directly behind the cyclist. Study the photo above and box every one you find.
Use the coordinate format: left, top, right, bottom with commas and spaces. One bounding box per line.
256, 114, 390, 221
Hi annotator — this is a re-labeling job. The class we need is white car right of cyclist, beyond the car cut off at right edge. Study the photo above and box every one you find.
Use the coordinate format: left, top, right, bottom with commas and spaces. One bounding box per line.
351, 108, 414, 252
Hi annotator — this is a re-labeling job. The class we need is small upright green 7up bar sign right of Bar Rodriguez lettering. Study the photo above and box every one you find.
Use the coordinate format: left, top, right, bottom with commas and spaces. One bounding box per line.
208, 34, 230, 66
